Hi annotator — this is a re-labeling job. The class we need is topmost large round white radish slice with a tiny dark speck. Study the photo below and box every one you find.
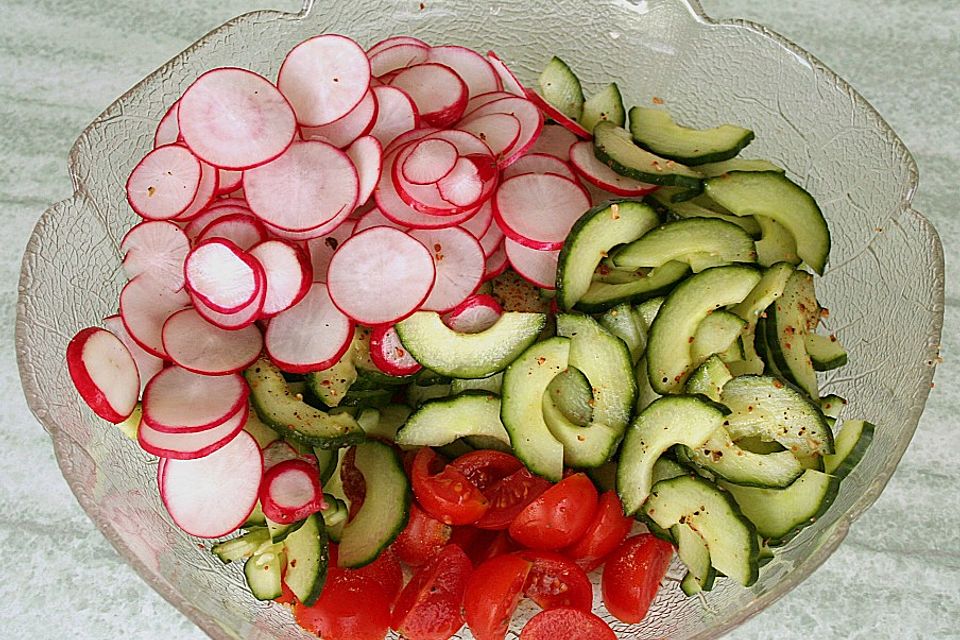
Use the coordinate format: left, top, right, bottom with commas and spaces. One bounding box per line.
277, 34, 370, 127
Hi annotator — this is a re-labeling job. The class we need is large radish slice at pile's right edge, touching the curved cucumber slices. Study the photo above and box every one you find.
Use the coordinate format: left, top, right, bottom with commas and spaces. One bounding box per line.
493, 173, 590, 251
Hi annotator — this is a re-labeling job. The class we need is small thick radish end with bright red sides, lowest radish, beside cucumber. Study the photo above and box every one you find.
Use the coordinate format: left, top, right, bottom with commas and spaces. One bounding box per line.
260, 460, 323, 524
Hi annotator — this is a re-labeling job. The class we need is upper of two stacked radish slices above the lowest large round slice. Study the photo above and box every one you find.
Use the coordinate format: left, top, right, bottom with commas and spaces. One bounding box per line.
143, 365, 250, 433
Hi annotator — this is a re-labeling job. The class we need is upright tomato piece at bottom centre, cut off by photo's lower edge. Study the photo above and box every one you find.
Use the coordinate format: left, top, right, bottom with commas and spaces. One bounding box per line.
463, 554, 531, 640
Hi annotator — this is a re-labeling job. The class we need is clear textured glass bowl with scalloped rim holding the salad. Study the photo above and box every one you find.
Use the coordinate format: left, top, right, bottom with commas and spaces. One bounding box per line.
16, 0, 943, 640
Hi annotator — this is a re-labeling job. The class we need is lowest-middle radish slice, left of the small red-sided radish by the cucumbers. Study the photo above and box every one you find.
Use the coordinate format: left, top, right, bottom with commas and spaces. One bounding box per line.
264, 282, 357, 373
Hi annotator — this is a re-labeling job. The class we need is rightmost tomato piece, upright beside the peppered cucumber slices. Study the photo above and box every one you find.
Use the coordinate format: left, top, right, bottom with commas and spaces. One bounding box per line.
600, 533, 673, 624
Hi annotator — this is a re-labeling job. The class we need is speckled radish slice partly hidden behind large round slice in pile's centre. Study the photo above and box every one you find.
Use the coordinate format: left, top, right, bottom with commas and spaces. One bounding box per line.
409, 227, 486, 312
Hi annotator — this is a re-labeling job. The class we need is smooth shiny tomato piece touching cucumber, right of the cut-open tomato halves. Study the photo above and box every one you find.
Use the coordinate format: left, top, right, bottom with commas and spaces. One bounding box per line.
510, 473, 597, 550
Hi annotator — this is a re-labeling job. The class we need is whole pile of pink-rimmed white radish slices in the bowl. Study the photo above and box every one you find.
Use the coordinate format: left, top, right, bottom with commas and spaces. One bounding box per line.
67, 35, 636, 537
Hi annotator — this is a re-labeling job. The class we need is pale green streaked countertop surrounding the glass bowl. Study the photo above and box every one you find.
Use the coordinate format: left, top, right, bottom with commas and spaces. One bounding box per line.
0, 0, 960, 640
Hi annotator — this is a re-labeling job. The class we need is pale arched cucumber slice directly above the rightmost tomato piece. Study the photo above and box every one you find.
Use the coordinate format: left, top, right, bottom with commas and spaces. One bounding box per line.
617, 395, 724, 516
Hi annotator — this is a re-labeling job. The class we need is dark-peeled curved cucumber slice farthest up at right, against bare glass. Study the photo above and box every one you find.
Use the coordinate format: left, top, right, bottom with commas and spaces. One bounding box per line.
630, 107, 754, 165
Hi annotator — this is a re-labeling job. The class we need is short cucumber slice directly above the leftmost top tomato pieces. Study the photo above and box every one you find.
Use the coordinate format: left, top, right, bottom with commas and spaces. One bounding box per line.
396, 393, 510, 447
